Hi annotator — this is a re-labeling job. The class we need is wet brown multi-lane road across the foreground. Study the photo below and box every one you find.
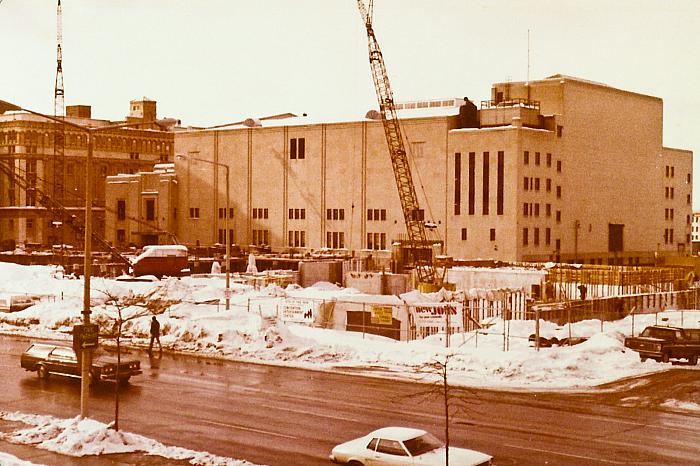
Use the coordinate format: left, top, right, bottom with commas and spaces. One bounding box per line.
0, 336, 700, 466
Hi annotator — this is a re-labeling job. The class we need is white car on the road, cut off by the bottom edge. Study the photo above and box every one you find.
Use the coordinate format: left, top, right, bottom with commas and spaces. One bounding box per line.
329, 427, 492, 466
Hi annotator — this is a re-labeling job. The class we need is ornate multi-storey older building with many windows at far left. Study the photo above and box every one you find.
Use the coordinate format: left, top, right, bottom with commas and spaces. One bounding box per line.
0, 98, 174, 249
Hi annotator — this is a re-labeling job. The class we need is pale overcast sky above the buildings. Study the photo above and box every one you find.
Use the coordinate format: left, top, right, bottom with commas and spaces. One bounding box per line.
0, 0, 700, 202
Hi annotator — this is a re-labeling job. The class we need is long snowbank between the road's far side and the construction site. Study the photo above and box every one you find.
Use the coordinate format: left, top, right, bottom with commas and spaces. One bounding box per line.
0, 263, 700, 389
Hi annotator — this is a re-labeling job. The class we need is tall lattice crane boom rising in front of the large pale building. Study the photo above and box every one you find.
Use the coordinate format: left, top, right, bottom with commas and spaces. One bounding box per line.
357, 0, 443, 291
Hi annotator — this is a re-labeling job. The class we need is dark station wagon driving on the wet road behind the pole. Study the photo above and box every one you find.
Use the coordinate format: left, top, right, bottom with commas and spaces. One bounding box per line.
20, 343, 142, 383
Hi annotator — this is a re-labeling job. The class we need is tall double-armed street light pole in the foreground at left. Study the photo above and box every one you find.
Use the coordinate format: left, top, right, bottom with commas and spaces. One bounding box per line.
0, 100, 179, 418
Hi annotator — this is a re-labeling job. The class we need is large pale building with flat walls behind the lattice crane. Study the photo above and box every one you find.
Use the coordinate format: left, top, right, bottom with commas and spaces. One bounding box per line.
105, 75, 692, 264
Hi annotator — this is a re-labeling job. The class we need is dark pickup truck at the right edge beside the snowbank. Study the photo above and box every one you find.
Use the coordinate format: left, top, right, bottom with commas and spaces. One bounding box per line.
625, 325, 700, 365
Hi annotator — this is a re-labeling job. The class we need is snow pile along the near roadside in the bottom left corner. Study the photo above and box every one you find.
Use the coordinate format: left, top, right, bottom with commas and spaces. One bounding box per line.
0, 411, 252, 466
